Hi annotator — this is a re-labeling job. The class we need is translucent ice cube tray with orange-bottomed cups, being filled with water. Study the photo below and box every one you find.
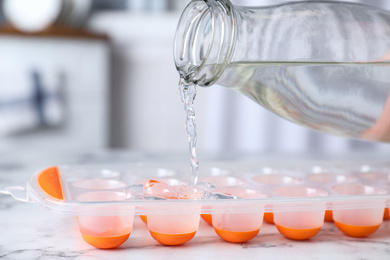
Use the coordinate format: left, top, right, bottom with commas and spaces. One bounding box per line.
0, 161, 390, 249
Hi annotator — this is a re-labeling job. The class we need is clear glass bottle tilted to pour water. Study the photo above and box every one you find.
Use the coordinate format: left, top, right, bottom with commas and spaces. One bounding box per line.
174, 0, 390, 142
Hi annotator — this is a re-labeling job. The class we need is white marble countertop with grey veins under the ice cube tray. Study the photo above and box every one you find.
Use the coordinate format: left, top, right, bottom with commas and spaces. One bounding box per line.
0, 151, 390, 260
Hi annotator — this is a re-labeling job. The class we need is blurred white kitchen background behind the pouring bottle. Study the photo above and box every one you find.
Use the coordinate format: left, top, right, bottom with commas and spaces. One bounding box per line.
0, 0, 390, 157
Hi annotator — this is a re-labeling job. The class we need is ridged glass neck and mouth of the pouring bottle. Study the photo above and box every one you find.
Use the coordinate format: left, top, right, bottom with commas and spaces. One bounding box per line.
174, 0, 236, 87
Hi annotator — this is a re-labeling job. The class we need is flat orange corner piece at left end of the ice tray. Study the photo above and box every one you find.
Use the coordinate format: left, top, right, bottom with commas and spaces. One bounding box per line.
37, 167, 64, 200
